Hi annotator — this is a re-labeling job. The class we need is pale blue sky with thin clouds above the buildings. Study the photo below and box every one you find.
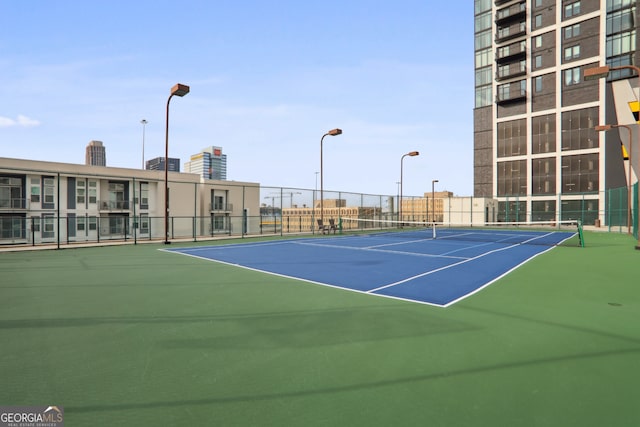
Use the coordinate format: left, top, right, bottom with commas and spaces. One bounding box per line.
0, 0, 474, 196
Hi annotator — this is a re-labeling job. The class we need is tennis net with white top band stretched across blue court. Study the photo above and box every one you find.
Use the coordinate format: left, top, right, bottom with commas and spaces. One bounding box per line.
338, 218, 584, 246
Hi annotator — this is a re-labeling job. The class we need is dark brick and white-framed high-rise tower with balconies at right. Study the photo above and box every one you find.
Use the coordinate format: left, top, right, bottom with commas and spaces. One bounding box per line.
474, 0, 640, 224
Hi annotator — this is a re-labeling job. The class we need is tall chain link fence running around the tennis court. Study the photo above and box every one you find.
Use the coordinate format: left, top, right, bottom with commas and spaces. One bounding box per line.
0, 183, 638, 246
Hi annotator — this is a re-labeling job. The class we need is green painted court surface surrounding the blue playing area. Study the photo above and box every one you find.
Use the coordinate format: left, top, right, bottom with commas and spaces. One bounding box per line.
0, 232, 640, 427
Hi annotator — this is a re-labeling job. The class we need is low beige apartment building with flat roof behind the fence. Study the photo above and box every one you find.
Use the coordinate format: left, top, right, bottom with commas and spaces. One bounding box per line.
0, 157, 260, 244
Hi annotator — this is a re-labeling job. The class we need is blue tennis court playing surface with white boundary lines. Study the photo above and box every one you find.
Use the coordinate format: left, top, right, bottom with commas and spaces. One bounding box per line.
168, 227, 575, 307
